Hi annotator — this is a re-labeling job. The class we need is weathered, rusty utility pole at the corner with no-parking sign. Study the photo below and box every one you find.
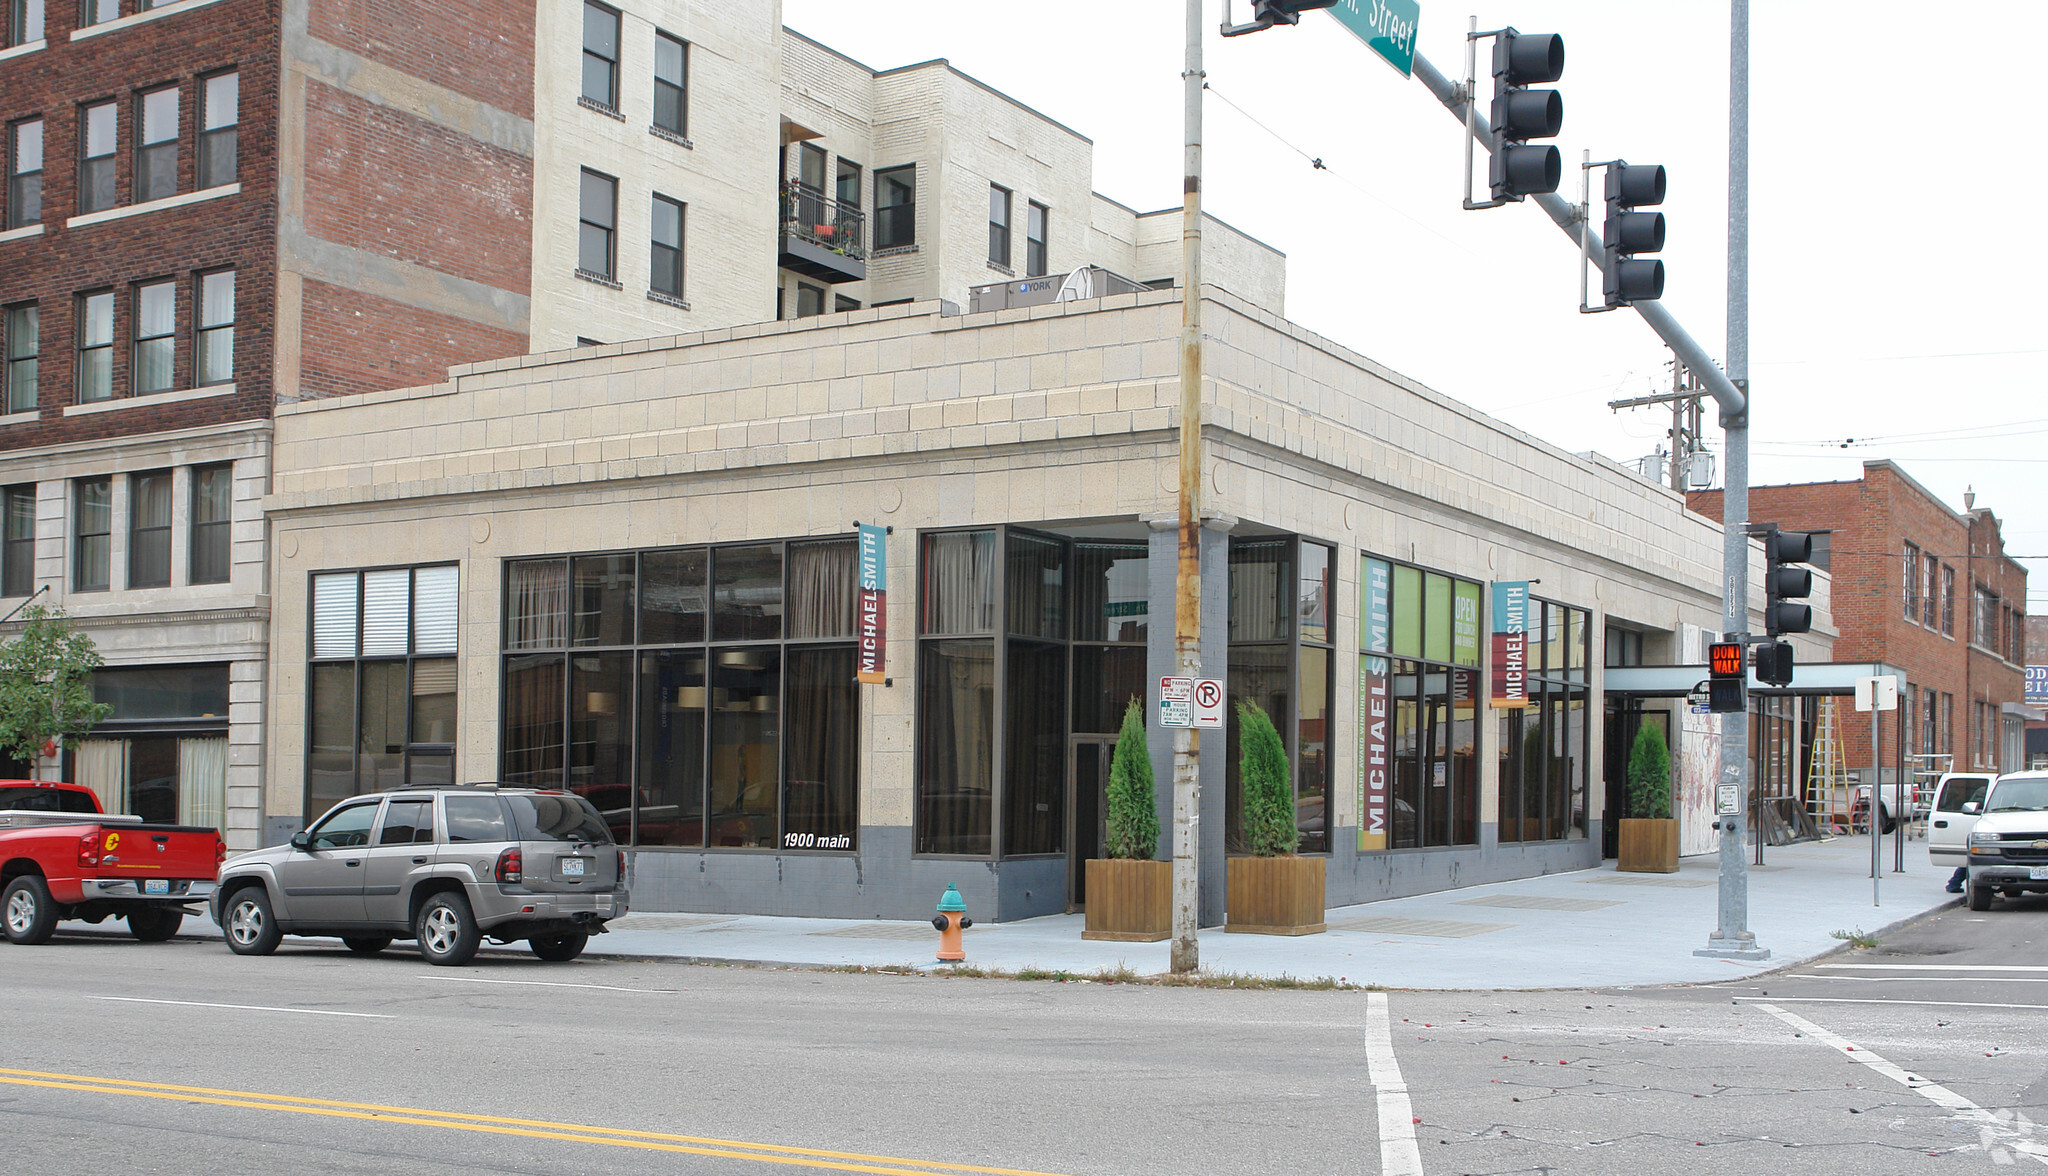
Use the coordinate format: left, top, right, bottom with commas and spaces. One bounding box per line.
1171, 0, 1202, 973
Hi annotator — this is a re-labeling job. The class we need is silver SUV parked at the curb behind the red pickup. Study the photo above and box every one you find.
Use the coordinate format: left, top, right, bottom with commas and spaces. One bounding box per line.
211, 785, 627, 965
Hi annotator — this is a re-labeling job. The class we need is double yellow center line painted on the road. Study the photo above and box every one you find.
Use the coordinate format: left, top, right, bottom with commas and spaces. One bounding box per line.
0, 1069, 1059, 1176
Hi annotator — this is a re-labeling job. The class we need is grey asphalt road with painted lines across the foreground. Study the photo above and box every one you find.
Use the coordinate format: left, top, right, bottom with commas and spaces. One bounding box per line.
0, 899, 2048, 1176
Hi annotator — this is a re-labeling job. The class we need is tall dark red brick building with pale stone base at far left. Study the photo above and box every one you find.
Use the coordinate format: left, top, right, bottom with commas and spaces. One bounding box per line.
0, 0, 535, 848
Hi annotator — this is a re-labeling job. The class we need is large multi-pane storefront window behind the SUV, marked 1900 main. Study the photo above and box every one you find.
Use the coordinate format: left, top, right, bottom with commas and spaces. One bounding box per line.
502, 539, 860, 850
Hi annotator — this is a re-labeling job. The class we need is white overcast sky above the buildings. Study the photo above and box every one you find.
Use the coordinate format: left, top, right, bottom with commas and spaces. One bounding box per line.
782, 0, 2048, 613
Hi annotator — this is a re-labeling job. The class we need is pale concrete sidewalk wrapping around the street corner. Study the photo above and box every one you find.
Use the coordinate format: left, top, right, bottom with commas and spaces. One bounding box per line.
159, 836, 1956, 990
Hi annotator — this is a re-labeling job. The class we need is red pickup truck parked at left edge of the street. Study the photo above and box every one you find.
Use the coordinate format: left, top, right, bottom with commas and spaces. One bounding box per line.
0, 781, 227, 942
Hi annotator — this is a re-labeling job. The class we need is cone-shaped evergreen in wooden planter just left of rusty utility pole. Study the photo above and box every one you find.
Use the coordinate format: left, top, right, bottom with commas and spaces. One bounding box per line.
1081, 699, 1174, 942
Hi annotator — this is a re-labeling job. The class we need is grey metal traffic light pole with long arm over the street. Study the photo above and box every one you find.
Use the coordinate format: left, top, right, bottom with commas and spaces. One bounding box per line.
1415, 16, 1769, 959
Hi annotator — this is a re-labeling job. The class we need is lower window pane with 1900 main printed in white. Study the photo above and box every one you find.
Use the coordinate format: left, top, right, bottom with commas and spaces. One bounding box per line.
782, 647, 860, 850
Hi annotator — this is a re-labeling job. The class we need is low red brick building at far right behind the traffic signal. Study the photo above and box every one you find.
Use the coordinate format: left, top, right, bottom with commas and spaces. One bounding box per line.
1686, 461, 2028, 786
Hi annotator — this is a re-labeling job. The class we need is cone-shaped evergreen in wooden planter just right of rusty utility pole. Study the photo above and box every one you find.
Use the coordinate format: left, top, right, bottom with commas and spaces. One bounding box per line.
1223, 701, 1323, 934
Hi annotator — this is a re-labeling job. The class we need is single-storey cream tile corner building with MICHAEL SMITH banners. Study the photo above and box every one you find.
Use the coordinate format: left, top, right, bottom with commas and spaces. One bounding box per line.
264, 291, 1827, 922
